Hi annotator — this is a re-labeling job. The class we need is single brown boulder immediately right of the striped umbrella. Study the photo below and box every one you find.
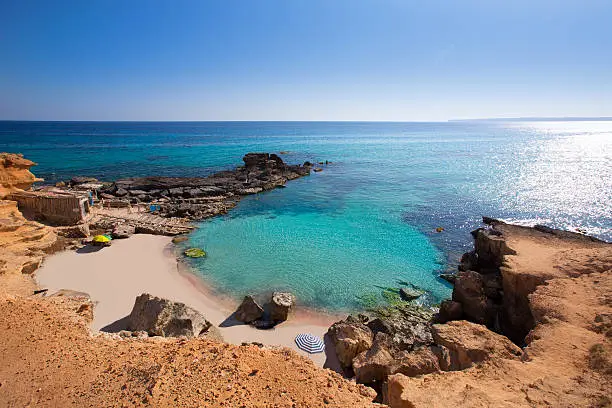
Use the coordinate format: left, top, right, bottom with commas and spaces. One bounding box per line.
327, 316, 374, 368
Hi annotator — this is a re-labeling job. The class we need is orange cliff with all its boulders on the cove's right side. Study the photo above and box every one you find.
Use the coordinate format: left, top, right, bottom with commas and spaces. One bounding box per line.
328, 217, 612, 407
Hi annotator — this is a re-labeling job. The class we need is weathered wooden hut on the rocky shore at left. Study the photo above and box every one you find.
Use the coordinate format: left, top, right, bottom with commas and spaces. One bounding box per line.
10, 191, 90, 225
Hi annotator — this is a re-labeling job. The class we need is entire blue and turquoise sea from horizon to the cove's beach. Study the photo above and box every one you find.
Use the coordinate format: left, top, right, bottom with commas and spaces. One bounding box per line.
0, 121, 612, 311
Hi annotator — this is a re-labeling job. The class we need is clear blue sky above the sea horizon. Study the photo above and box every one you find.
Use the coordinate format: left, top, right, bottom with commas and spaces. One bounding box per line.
0, 0, 612, 121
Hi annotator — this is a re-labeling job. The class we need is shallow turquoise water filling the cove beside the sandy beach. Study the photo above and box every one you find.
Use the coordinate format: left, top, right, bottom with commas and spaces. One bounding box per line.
184, 177, 448, 310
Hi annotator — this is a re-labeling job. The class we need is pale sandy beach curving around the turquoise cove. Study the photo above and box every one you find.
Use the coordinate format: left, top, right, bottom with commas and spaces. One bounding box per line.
36, 234, 338, 366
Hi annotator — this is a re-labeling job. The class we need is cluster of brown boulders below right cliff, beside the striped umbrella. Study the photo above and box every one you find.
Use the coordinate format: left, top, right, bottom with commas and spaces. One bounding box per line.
329, 317, 521, 389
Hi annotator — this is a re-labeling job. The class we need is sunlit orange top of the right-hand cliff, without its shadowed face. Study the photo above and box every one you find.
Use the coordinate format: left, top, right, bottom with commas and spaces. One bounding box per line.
386, 224, 612, 408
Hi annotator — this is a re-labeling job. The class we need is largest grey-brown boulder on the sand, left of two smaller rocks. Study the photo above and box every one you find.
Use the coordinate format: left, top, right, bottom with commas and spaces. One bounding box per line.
127, 293, 219, 337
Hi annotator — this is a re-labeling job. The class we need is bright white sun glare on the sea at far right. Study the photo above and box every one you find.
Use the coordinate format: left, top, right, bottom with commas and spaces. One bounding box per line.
502, 121, 612, 235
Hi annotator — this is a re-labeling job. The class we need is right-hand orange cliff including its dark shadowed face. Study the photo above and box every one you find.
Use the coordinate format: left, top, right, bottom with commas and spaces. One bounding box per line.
383, 219, 612, 408
